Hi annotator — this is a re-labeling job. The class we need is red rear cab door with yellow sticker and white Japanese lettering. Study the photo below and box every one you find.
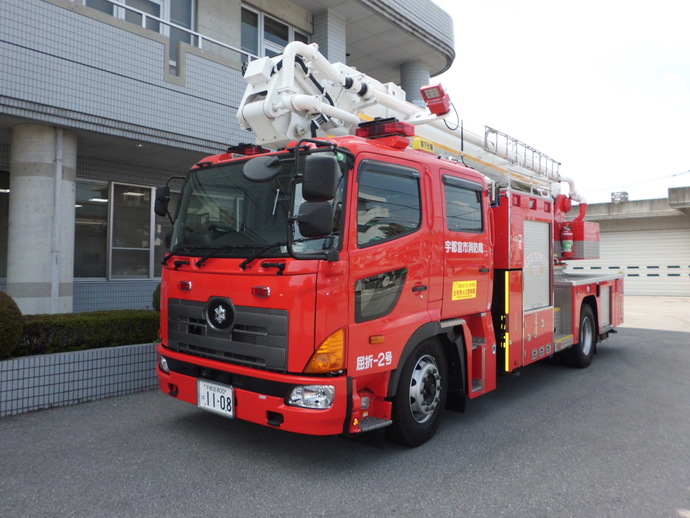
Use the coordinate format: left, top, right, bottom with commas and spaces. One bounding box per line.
441, 169, 493, 318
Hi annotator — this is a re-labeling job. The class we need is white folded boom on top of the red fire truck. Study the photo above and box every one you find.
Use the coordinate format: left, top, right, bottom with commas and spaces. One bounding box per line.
237, 42, 583, 201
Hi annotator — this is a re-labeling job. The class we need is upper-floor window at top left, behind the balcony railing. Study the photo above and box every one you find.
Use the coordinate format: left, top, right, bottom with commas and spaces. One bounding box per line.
84, 0, 194, 65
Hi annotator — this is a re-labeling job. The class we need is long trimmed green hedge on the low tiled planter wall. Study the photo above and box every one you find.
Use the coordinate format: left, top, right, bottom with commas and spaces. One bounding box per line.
12, 310, 160, 357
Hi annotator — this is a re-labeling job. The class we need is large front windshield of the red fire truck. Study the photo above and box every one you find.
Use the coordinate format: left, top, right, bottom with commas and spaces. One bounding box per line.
171, 151, 345, 258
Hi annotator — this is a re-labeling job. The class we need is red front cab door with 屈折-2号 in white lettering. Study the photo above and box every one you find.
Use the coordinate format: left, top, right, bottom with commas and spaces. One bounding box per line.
348, 155, 430, 374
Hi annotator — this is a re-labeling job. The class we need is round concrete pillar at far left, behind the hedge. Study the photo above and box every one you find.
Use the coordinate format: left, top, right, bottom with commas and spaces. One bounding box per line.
7, 124, 77, 315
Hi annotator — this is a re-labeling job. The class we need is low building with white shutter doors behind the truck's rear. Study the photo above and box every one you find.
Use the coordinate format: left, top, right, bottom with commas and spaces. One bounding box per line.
570, 187, 690, 297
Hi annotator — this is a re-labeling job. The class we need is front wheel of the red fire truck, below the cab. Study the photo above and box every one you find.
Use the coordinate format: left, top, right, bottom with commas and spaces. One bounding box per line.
386, 339, 449, 446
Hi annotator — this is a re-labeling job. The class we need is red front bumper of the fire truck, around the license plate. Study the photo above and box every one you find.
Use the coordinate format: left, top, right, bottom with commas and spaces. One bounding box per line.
158, 344, 352, 435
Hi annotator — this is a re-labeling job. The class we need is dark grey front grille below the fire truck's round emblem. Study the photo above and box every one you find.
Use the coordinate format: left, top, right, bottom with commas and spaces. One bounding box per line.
168, 299, 288, 371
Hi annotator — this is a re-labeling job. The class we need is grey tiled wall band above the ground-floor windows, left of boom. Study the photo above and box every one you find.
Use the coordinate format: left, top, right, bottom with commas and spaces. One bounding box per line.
0, 0, 251, 152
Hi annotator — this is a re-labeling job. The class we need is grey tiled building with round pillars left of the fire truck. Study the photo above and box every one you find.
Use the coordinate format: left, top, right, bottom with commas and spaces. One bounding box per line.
0, 0, 455, 314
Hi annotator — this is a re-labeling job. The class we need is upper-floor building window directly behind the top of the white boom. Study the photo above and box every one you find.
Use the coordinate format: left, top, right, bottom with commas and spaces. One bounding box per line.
241, 7, 309, 57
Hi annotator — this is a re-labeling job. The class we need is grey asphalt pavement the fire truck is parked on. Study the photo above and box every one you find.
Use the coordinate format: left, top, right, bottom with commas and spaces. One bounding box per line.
0, 301, 690, 518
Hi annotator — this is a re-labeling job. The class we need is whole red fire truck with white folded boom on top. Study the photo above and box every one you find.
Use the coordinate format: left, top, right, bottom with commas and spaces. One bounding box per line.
156, 43, 623, 446
